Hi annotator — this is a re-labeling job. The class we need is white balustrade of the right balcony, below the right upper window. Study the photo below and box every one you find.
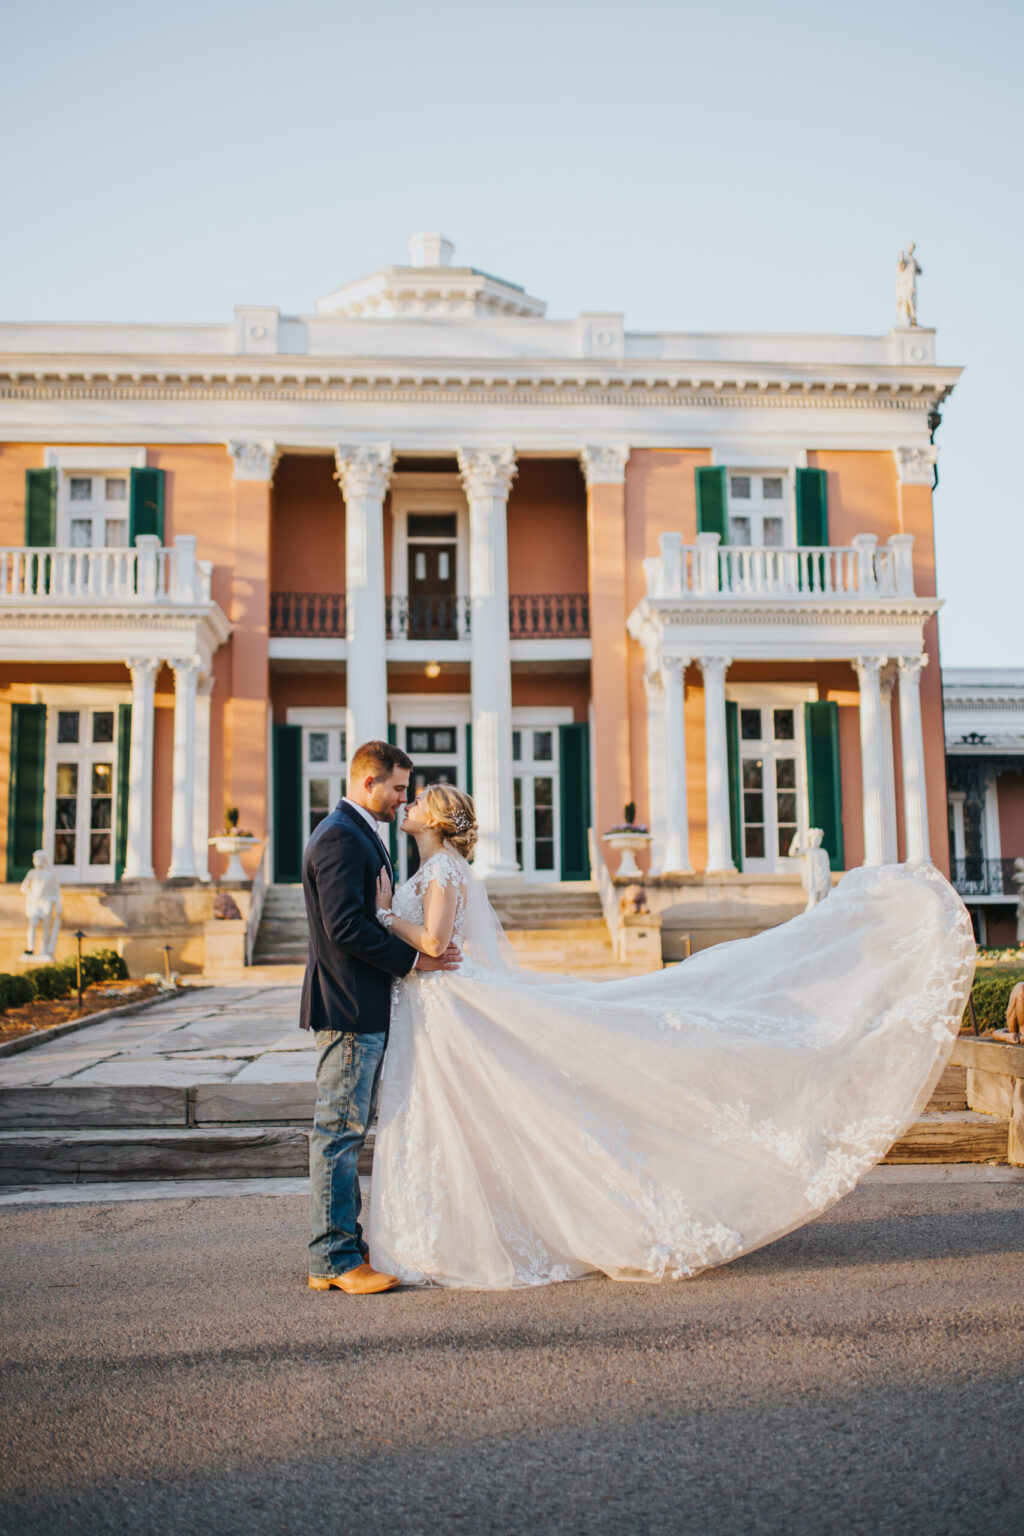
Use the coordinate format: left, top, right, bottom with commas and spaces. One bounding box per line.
643, 533, 913, 601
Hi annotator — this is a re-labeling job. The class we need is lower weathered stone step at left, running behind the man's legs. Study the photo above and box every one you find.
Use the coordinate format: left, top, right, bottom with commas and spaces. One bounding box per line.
0, 1126, 328, 1186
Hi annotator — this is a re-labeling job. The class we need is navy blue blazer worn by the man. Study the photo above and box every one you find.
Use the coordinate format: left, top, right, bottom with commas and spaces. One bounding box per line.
299, 800, 416, 1035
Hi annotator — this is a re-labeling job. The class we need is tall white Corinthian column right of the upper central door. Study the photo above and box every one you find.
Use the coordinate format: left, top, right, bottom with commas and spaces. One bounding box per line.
459, 449, 519, 876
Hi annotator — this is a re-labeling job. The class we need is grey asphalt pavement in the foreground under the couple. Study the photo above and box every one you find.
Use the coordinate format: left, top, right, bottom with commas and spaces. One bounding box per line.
0, 1170, 1024, 1536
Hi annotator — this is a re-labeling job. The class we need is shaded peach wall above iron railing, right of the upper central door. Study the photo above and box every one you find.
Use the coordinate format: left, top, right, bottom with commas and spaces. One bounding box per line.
508, 459, 586, 594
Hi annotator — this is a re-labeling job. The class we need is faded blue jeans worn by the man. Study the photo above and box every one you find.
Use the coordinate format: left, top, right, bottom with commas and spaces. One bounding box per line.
309, 1029, 387, 1279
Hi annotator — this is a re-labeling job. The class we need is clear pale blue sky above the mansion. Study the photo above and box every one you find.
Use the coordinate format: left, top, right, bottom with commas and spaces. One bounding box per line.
0, 0, 1024, 667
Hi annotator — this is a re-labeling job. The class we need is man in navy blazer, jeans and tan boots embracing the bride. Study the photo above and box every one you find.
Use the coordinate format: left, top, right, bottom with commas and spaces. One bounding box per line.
299, 742, 461, 1296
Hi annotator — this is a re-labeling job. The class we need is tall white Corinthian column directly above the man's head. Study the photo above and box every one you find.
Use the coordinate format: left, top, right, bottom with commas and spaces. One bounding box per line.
335, 442, 395, 759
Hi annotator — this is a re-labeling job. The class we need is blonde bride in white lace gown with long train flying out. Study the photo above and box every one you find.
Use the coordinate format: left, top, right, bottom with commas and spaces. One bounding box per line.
368, 785, 975, 1289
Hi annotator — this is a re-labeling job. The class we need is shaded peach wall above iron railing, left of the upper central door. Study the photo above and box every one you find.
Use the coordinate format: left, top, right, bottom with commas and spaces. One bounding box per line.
270, 453, 343, 591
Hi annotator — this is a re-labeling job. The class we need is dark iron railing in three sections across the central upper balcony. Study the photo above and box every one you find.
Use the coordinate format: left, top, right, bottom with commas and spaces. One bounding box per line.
270, 591, 590, 641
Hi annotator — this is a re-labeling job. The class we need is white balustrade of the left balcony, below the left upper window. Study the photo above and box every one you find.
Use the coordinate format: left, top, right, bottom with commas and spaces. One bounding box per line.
0, 535, 213, 607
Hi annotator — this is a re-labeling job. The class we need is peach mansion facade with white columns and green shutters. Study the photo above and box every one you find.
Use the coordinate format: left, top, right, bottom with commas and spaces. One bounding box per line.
0, 235, 960, 966
